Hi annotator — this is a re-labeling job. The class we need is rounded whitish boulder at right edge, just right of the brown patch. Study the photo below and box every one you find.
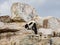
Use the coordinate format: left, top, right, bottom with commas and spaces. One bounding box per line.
44, 17, 60, 30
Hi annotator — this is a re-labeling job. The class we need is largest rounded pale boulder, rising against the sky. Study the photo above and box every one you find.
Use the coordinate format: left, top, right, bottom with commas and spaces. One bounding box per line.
11, 3, 37, 21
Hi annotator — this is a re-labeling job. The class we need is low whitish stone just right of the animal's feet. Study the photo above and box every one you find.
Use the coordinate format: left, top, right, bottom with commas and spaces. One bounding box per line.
38, 28, 53, 39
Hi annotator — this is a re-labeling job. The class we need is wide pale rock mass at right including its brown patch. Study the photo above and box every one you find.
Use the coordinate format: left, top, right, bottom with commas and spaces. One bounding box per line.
33, 16, 60, 30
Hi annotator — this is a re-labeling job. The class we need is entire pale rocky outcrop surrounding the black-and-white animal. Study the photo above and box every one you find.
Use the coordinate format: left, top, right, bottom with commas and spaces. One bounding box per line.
0, 3, 60, 45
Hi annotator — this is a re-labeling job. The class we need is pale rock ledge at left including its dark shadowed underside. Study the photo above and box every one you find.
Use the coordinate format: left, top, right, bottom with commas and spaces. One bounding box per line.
0, 22, 24, 33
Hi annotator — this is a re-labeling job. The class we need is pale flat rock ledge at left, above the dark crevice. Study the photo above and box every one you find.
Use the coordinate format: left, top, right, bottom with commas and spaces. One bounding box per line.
0, 22, 25, 30
